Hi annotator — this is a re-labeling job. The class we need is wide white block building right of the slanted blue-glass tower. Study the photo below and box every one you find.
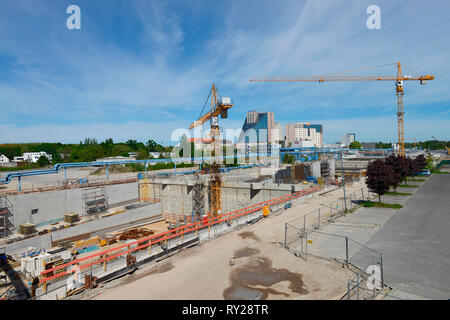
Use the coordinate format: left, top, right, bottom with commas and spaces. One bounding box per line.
285, 122, 323, 148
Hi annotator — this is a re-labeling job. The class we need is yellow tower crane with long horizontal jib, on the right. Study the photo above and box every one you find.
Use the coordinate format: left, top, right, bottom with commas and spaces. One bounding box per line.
250, 62, 434, 157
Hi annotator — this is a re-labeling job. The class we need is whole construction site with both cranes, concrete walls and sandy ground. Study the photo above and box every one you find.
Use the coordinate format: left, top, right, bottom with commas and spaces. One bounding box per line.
0, 63, 446, 300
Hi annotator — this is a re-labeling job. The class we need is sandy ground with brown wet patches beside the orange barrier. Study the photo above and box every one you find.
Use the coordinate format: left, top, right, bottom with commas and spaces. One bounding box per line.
89, 182, 363, 300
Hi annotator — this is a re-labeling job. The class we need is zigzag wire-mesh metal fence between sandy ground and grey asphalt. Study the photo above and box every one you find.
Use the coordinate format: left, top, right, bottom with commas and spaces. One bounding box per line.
284, 188, 390, 299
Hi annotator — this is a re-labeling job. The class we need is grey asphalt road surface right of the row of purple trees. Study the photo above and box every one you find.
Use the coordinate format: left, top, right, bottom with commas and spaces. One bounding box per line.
366, 174, 450, 299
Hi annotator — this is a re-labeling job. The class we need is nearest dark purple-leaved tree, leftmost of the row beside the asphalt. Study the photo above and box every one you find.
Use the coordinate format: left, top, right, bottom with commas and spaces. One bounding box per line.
366, 159, 395, 203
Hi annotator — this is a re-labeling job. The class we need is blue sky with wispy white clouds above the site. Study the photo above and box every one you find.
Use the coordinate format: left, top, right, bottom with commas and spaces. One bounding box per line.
0, 0, 450, 144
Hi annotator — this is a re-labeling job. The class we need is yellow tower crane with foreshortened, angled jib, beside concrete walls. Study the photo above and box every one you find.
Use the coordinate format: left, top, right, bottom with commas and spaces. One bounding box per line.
189, 84, 233, 217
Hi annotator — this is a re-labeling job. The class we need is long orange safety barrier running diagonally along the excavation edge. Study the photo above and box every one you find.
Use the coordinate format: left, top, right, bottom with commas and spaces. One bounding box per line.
40, 187, 320, 283
